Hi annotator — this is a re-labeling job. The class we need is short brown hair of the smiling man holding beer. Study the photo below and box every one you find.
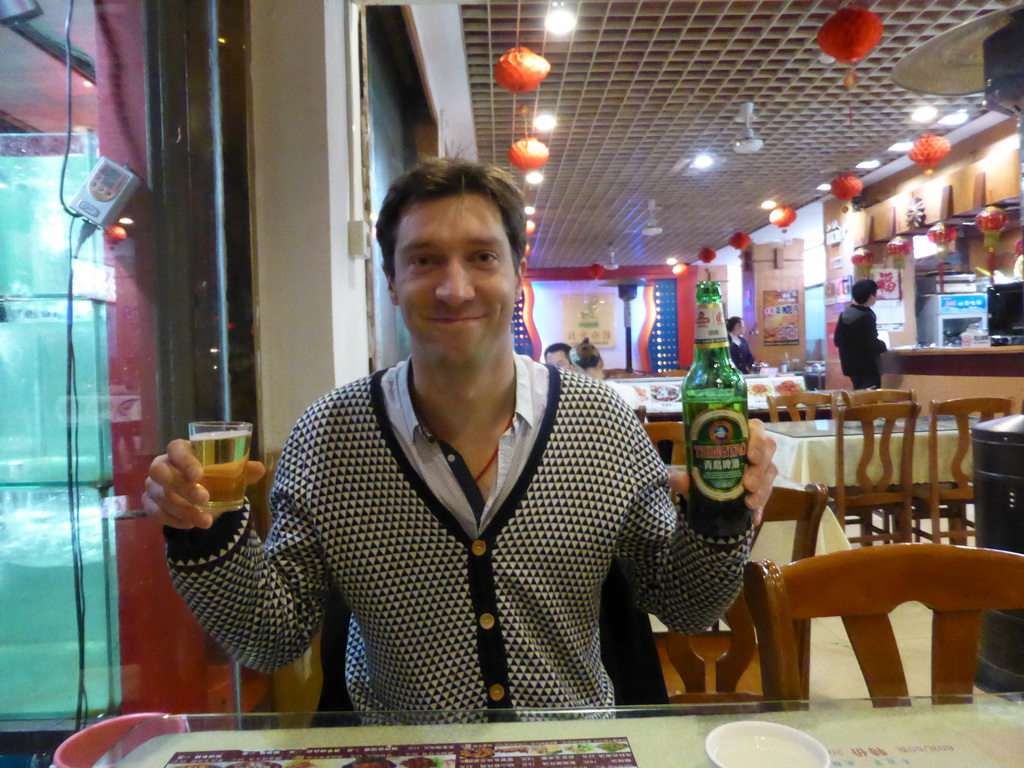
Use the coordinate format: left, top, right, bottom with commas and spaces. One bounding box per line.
377, 158, 526, 280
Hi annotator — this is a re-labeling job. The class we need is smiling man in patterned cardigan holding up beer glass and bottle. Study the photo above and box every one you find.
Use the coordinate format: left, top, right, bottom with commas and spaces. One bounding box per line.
143, 161, 775, 710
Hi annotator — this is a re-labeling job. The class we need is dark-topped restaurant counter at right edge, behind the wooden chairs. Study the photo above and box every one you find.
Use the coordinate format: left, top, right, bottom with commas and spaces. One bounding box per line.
882, 346, 1024, 413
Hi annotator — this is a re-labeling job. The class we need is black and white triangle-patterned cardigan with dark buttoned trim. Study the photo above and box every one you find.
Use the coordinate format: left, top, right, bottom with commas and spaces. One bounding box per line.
165, 369, 750, 710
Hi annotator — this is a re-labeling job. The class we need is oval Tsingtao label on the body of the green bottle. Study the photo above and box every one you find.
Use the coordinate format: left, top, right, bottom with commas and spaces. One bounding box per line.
689, 409, 750, 502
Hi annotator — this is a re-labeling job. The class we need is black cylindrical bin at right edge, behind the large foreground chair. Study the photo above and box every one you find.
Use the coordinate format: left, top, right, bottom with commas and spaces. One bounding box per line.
971, 415, 1024, 691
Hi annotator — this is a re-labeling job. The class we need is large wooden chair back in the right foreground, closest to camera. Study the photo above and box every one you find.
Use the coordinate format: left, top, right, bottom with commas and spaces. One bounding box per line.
744, 544, 1024, 707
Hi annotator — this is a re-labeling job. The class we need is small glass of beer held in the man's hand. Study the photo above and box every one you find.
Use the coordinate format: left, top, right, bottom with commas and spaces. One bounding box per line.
188, 421, 253, 512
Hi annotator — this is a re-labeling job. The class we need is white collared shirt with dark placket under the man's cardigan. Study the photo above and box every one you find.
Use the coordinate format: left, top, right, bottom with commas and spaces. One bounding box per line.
381, 354, 550, 538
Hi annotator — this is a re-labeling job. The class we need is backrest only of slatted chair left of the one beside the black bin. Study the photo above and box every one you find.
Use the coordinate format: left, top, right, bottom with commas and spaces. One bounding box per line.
835, 401, 921, 507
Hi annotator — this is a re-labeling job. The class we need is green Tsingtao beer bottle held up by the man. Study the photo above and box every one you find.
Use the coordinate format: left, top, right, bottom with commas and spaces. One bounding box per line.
683, 283, 753, 541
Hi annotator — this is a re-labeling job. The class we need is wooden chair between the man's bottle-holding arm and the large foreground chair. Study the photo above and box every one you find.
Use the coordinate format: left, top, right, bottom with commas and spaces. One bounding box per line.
664, 484, 827, 703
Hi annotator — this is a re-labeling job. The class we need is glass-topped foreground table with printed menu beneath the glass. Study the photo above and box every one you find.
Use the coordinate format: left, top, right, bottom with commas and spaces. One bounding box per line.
96, 694, 1024, 768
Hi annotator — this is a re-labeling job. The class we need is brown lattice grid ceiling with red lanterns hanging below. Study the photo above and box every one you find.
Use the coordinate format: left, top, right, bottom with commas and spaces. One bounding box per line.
462, 0, 1016, 267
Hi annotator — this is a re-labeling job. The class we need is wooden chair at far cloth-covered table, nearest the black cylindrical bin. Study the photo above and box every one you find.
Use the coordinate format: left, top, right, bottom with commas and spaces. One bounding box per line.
911, 397, 1011, 544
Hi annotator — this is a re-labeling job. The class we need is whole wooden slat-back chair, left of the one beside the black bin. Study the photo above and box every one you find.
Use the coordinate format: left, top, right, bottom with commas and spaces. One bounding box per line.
829, 402, 921, 544
